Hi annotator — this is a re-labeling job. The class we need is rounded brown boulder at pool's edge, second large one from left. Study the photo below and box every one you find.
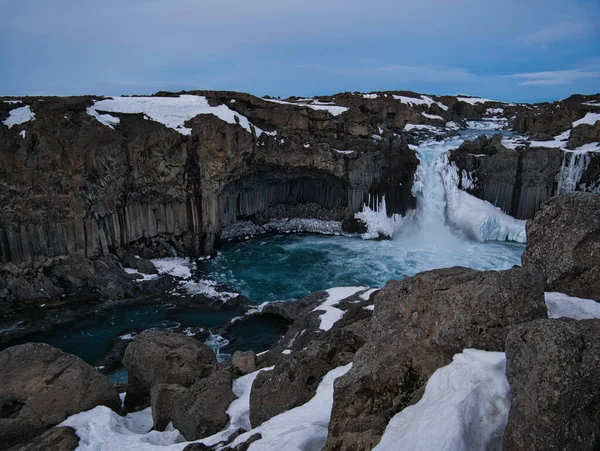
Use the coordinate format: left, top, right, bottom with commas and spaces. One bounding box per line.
123, 330, 217, 409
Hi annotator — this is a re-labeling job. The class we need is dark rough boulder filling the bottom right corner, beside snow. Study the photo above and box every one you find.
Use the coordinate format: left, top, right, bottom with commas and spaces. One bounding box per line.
504, 319, 600, 451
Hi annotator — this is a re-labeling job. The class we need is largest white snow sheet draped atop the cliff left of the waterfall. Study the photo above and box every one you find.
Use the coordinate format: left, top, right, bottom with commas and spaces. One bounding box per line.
86, 95, 276, 136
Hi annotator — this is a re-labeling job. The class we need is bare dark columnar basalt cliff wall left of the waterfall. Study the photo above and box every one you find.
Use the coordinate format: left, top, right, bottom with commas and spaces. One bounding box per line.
0, 91, 420, 309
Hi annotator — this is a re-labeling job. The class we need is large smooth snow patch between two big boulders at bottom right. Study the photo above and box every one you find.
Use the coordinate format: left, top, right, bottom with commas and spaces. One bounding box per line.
373, 349, 510, 451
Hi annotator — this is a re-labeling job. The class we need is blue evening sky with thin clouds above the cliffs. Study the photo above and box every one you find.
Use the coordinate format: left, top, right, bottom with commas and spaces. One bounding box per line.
0, 0, 600, 101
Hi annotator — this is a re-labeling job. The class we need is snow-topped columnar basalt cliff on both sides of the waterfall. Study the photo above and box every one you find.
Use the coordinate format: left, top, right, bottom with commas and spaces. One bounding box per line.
0, 91, 598, 312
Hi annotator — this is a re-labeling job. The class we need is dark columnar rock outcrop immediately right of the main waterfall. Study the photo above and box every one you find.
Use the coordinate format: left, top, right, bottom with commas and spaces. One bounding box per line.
450, 135, 562, 219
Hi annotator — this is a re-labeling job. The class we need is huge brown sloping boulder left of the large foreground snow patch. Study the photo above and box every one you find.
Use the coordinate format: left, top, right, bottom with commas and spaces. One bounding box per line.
326, 267, 547, 450
